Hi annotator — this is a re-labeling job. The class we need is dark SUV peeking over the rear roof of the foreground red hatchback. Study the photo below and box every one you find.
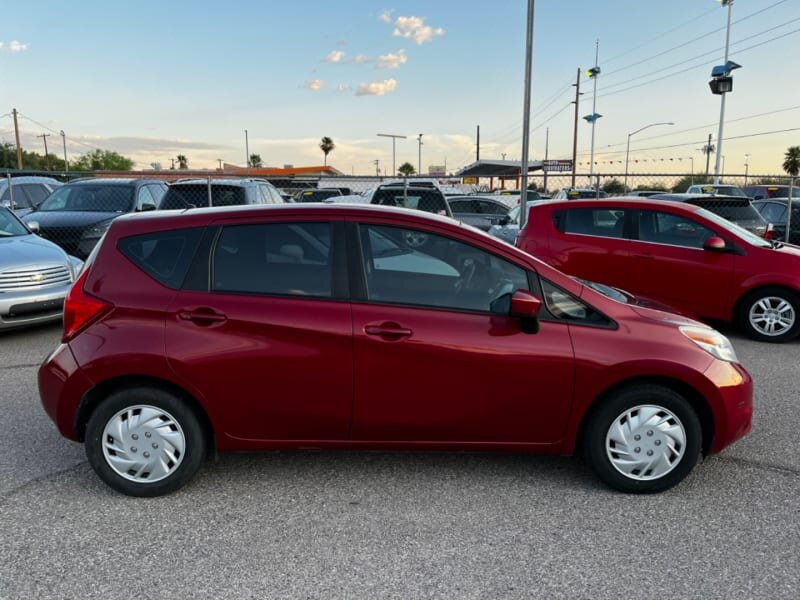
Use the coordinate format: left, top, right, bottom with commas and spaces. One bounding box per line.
159, 179, 284, 210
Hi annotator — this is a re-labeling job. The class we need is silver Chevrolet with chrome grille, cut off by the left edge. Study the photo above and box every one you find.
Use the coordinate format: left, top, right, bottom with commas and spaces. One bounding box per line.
0, 206, 83, 331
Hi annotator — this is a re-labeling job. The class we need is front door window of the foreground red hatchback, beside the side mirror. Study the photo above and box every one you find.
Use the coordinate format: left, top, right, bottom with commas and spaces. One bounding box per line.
361, 225, 528, 312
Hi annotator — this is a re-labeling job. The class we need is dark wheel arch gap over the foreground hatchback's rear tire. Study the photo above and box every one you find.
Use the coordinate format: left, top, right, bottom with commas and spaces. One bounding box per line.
75, 375, 216, 455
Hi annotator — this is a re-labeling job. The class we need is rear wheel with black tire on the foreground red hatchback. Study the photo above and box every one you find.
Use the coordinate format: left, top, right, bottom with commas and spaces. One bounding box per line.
84, 387, 206, 497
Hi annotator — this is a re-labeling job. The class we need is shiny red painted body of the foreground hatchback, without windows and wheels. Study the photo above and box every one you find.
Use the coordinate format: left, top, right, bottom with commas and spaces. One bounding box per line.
34, 201, 752, 460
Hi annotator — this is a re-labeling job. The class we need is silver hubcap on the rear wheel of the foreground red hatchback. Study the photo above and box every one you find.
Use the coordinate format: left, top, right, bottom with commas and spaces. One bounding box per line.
103, 405, 186, 483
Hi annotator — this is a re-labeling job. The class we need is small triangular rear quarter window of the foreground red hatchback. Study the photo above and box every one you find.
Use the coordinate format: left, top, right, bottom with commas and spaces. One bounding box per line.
120, 227, 203, 290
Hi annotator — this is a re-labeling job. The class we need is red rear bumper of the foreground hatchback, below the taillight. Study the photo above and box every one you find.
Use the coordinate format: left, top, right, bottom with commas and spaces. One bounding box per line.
39, 344, 92, 441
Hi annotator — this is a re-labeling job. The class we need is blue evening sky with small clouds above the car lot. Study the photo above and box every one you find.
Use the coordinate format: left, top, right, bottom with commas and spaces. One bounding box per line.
0, 0, 800, 174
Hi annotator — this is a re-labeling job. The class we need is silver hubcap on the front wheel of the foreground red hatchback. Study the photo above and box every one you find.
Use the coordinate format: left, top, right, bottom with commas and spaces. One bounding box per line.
606, 404, 686, 481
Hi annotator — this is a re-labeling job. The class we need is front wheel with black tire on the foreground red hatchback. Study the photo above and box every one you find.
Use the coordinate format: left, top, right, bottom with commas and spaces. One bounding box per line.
583, 384, 703, 494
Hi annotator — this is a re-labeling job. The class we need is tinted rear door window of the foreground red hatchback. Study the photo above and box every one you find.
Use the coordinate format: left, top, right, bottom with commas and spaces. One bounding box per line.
212, 223, 332, 297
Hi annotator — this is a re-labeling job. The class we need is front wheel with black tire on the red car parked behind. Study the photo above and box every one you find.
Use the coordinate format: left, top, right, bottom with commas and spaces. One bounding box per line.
736, 286, 800, 344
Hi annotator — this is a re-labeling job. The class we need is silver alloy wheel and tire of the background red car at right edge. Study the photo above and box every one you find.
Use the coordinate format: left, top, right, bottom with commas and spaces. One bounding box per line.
738, 287, 800, 342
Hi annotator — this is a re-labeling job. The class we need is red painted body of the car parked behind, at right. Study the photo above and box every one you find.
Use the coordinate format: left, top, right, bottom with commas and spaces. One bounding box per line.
517, 198, 800, 321
